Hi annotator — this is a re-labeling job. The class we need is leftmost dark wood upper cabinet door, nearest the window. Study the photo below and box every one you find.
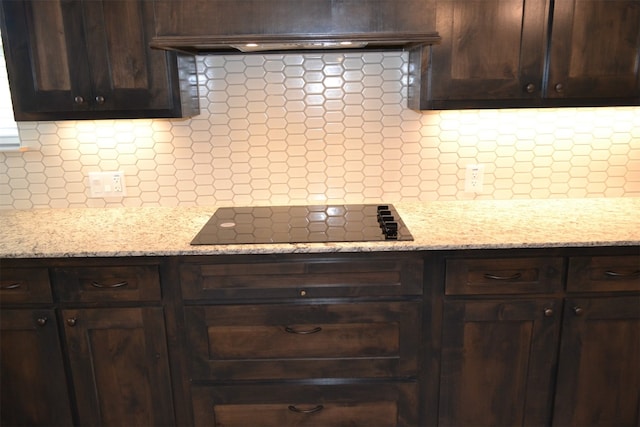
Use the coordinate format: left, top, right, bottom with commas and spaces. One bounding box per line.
0, 0, 91, 116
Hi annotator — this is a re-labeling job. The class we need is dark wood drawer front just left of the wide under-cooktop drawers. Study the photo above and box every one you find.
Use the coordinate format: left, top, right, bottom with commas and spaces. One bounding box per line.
53, 265, 161, 302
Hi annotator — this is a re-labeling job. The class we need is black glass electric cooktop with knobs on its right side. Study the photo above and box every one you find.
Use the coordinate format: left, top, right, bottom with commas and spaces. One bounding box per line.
191, 205, 413, 245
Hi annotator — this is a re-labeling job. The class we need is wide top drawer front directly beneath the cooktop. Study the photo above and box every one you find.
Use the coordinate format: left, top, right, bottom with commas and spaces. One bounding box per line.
180, 253, 422, 299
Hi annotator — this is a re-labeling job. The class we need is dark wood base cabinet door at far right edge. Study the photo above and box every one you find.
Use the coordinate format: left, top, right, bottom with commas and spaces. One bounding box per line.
553, 296, 640, 427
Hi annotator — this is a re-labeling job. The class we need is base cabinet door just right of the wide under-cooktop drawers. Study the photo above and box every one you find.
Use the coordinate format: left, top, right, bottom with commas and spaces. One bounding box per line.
439, 299, 560, 427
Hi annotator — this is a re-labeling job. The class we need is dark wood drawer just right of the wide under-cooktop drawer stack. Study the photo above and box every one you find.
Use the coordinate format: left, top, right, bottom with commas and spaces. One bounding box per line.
445, 258, 563, 295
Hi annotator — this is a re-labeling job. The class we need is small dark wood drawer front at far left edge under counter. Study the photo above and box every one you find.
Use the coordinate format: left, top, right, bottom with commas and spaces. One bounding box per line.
0, 267, 53, 304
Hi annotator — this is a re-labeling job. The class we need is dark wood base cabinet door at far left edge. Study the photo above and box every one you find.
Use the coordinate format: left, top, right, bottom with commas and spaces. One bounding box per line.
0, 309, 73, 427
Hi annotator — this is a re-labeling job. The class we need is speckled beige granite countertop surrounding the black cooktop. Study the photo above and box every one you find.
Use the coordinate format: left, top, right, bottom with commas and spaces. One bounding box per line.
0, 198, 640, 258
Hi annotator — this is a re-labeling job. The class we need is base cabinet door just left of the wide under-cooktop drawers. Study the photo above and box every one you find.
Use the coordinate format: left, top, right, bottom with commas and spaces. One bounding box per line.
62, 307, 175, 426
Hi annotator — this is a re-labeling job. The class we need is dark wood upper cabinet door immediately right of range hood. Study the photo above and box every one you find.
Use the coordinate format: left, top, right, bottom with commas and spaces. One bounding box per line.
424, 0, 548, 108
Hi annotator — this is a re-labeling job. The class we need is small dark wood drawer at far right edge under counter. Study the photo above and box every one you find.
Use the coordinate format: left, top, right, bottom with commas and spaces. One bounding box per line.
567, 255, 640, 292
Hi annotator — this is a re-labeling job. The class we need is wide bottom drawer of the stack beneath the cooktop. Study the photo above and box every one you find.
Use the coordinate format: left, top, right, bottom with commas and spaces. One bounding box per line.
191, 382, 420, 427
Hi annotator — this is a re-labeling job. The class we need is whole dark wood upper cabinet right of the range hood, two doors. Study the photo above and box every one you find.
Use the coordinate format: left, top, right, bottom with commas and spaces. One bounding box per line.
409, 0, 640, 110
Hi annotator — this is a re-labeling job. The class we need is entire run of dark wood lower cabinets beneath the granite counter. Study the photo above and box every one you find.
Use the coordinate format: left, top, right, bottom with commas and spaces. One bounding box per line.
0, 247, 640, 427
